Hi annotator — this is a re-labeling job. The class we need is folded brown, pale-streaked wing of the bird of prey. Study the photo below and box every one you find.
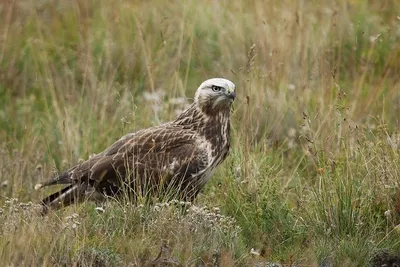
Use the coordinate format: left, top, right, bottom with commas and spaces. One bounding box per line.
70, 124, 209, 180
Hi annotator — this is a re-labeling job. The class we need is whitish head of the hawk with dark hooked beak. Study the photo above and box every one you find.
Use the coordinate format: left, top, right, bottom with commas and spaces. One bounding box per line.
194, 78, 236, 113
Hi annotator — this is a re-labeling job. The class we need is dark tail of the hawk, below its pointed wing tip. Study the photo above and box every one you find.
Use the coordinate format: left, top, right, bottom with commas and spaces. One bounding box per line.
41, 184, 85, 215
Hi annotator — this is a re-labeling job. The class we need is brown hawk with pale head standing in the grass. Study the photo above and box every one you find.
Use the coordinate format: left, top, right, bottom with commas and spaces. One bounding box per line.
35, 78, 235, 214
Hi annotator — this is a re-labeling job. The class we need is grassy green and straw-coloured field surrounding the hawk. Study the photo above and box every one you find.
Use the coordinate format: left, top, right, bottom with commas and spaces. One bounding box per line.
0, 0, 400, 267
